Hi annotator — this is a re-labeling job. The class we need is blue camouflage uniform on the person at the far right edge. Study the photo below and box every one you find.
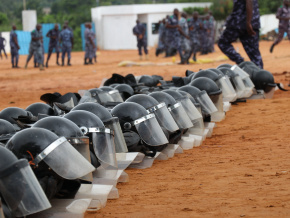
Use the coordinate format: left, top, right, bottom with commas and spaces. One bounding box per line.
274, 6, 290, 45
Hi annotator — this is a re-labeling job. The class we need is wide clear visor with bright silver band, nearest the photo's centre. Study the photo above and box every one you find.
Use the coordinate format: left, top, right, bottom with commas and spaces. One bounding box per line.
134, 114, 168, 146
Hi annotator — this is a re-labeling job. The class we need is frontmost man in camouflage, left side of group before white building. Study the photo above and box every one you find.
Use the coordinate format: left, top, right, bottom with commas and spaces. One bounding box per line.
166, 9, 189, 64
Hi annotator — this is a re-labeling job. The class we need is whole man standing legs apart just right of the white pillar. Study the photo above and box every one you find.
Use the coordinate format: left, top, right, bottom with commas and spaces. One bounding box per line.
25, 24, 44, 70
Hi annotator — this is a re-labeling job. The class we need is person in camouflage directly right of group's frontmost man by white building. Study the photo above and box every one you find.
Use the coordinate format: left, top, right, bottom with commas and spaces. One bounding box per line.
188, 11, 202, 61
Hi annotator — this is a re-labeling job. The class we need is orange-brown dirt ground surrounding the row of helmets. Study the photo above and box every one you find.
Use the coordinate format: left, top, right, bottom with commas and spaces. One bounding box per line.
0, 41, 290, 218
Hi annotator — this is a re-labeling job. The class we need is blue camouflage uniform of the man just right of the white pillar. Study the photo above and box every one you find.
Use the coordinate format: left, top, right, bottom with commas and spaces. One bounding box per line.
26, 29, 44, 65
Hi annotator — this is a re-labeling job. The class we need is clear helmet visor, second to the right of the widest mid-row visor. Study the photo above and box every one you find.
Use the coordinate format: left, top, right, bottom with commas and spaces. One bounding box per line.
168, 102, 193, 129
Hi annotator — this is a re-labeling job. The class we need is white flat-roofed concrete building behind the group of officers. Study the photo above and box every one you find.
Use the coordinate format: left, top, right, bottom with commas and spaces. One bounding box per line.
91, 2, 211, 50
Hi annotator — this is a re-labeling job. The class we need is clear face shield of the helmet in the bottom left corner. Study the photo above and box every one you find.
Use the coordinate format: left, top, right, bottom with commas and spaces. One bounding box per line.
0, 159, 51, 217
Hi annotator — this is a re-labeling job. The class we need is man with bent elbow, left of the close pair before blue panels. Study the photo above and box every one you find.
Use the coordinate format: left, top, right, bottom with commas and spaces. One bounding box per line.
45, 24, 60, 67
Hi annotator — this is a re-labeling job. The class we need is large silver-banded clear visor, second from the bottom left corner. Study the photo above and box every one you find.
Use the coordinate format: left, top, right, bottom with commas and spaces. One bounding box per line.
33, 137, 95, 180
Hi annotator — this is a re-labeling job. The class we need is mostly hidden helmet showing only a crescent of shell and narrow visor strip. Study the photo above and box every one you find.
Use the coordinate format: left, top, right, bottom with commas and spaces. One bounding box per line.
72, 102, 128, 153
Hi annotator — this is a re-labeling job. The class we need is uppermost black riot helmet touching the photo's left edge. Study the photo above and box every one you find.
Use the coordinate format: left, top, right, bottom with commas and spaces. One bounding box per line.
0, 107, 27, 130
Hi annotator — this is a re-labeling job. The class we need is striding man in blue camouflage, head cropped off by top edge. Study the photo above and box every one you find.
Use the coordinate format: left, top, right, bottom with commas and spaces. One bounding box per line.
218, 0, 263, 69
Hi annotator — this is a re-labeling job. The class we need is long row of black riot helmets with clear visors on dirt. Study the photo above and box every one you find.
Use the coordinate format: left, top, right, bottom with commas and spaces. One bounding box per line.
0, 62, 275, 217
